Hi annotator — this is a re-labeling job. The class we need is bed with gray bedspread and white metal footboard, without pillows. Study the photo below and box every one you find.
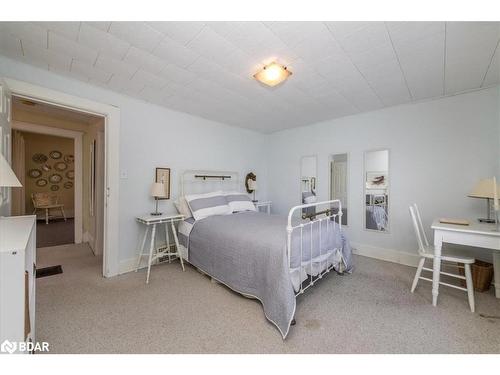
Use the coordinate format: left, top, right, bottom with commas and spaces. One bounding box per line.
178, 174, 352, 338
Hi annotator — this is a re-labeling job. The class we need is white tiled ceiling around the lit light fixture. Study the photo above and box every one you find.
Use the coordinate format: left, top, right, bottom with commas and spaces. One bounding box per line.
0, 22, 500, 133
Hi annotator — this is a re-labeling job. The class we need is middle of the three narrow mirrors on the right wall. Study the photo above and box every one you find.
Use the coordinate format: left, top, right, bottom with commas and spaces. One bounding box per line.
330, 154, 349, 225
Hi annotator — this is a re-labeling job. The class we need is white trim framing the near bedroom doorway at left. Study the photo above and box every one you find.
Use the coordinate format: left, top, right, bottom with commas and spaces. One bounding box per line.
5, 78, 120, 277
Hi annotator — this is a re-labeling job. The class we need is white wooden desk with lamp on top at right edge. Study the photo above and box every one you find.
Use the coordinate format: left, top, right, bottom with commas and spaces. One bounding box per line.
431, 219, 500, 306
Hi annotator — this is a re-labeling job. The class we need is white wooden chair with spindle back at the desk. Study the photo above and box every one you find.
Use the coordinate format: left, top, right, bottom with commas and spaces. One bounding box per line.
410, 204, 475, 312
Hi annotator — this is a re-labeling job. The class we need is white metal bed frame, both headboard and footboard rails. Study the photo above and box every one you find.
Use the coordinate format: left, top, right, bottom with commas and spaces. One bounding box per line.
181, 170, 345, 304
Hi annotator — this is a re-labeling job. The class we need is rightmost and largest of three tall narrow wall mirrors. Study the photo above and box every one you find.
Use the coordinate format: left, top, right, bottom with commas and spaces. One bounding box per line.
364, 150, 390, 232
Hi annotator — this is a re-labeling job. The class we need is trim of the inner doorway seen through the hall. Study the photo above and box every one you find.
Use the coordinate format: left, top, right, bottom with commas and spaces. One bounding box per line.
12, 121, 83, 243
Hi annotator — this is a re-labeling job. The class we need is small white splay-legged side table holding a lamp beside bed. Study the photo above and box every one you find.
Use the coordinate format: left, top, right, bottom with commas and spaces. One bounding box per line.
135, 214, 184, 284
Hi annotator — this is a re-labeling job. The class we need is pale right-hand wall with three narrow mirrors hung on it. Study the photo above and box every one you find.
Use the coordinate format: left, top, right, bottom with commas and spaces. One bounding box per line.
267, 88, 500, 263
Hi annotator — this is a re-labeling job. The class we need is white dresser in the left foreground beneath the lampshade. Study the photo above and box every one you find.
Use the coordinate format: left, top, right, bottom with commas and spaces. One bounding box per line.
0, 216, 36, 353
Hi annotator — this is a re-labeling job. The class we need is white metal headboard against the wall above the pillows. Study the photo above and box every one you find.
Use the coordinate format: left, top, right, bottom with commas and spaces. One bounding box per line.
181, 170, 241, 195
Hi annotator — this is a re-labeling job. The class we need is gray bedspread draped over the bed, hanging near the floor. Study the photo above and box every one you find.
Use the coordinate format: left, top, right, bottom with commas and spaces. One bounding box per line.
189, 212, 351, 338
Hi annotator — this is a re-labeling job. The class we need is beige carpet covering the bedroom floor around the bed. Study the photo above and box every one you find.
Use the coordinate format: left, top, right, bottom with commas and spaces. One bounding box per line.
36, 245, 500, 353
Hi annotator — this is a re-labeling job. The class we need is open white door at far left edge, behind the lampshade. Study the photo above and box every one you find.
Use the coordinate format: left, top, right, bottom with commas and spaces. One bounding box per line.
0, 78, 12, 216
